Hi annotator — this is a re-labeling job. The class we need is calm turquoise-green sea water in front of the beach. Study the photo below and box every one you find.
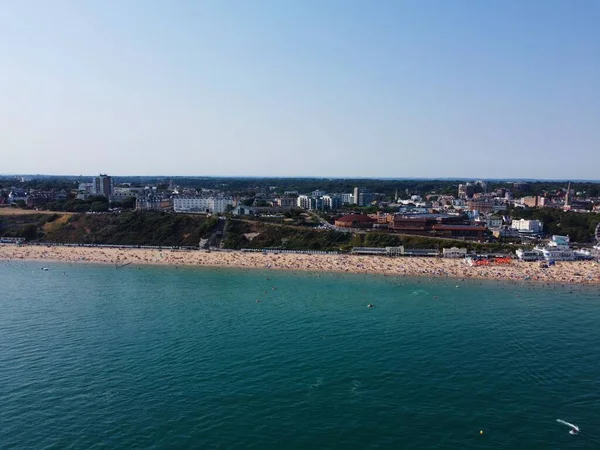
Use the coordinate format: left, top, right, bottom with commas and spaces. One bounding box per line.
0, 262, 600, 449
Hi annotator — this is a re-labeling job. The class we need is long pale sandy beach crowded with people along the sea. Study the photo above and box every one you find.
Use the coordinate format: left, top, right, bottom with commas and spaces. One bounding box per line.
0, 245, 600, 284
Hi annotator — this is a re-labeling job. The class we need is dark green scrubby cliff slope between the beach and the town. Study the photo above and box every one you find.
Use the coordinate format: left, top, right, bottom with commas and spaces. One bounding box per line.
0, 211, 515, 252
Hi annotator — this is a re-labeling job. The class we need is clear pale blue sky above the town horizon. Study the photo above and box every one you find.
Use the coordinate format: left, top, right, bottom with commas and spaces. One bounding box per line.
0, 0, 600, 179
